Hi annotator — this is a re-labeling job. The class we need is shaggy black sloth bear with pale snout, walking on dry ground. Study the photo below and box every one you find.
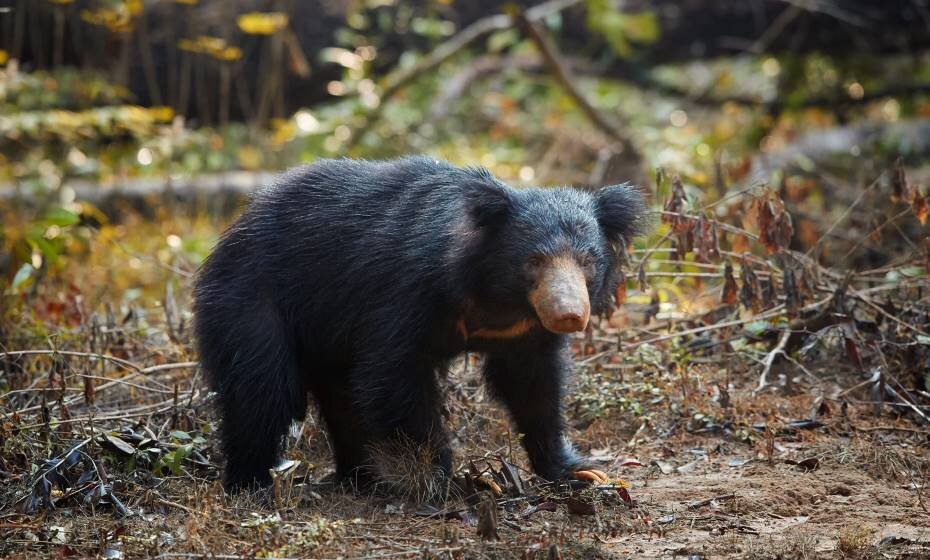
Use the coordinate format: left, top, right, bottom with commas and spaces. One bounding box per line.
194, 157, 646, 489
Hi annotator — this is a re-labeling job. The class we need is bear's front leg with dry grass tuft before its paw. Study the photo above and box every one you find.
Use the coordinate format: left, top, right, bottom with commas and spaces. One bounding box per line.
352, 360, 452, 501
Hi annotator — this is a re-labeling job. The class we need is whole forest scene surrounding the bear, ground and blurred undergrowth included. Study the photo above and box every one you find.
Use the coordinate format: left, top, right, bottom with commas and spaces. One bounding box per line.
0, 0, 930, 558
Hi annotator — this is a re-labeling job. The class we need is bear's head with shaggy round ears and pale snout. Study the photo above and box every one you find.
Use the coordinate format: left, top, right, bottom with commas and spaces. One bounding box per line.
467, 178, 647, 333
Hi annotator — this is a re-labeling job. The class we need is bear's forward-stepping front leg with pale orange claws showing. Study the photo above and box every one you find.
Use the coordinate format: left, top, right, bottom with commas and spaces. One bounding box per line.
485, 334, 608, 483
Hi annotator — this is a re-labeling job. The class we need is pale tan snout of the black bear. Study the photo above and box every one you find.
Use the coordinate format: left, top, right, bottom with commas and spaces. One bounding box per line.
529, 257, 591, 334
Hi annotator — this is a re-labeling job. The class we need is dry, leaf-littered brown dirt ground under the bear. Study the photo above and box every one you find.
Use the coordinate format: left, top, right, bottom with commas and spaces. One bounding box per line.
0, 336, 930, 559
